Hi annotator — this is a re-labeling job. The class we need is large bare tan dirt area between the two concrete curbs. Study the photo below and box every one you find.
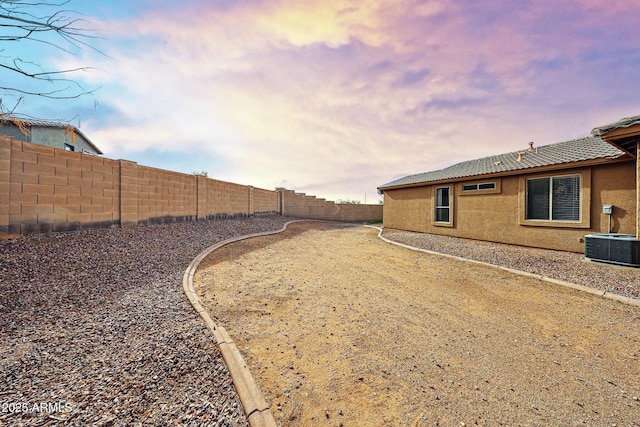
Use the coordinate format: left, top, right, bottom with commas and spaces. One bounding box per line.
195, 222, 640, 426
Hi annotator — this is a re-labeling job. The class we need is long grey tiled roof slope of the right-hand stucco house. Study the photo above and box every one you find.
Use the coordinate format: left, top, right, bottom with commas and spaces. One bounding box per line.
378, 137, 625, 190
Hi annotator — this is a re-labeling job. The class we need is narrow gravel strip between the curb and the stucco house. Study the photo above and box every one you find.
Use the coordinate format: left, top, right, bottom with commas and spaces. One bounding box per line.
382, 229, 640, 299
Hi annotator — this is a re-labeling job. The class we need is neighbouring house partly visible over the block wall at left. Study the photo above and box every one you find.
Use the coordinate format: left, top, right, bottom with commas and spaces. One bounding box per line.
0, 119, 103, 155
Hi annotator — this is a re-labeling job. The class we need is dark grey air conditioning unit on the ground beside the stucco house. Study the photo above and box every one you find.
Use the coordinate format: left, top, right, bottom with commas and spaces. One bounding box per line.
584, 233, 640, 267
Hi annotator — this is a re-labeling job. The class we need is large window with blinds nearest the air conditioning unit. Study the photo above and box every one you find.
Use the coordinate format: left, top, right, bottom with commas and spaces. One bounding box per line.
526, 175, 580, 221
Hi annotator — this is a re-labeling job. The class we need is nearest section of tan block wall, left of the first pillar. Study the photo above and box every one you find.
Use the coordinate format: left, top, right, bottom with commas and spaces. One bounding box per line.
0, 138, 120, 234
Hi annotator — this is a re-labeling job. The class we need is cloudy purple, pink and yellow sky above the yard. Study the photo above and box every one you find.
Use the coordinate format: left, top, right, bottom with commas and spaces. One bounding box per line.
0, 0, 640, 203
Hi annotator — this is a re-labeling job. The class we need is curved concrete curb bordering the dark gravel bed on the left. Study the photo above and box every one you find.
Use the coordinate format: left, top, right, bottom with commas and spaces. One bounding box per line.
182, 220, 309, 427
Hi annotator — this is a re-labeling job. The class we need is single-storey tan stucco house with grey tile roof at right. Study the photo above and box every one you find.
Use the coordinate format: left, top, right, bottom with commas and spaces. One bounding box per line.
378, 116, 640, 260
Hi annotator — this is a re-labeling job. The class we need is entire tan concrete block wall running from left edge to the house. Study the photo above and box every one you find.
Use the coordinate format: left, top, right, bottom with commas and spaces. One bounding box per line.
0, 136, 382, 234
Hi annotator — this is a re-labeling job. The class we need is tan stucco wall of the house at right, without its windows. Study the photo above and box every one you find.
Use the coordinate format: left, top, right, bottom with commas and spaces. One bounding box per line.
384, 162, 638, 252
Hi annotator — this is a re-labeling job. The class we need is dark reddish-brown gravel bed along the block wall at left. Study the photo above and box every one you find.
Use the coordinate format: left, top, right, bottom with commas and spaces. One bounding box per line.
0, 217, 290, 426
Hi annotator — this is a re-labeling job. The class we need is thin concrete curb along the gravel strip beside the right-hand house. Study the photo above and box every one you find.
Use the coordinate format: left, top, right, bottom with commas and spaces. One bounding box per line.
365, 225, 640, 307
